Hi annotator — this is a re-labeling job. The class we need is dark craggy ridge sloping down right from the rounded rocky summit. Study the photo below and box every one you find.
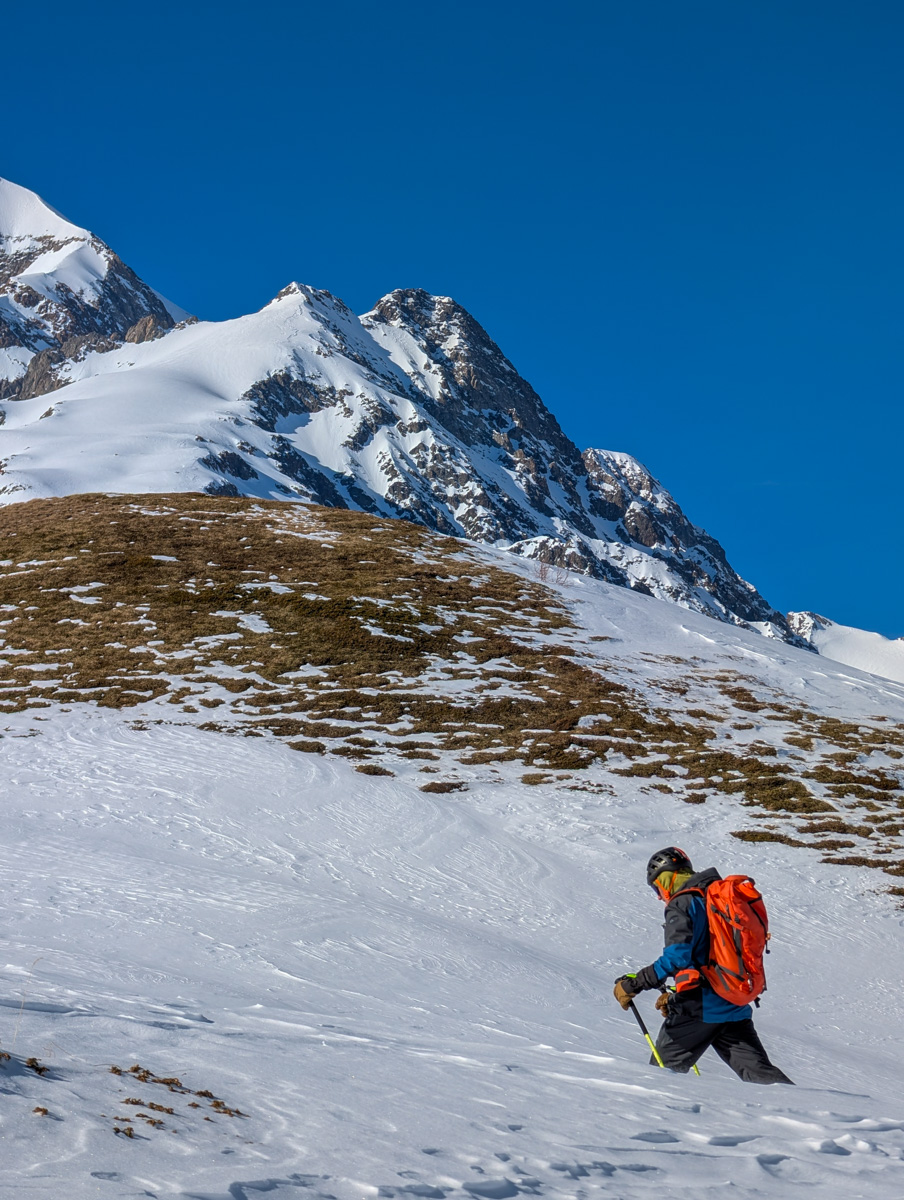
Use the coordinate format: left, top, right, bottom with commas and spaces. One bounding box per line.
361, 290, 795, 640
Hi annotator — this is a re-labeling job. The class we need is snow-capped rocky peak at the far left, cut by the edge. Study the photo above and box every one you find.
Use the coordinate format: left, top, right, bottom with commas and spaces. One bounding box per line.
0, 179, 187, 398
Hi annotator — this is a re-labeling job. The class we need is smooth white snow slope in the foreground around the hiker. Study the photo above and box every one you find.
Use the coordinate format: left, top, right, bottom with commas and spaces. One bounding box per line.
0, 709, 904, 1200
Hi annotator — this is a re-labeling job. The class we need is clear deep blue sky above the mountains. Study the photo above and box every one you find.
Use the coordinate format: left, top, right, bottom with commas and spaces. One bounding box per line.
7, 0, 904, 636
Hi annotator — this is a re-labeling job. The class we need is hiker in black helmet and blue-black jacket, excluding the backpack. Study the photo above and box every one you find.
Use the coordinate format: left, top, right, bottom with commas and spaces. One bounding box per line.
615, 846, 792, 1084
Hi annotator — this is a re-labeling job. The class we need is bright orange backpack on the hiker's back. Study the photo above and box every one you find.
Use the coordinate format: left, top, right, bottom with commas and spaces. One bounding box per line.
689, 875, 771, 1004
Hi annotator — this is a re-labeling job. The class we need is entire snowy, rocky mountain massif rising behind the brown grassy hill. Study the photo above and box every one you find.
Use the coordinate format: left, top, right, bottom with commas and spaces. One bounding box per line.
0, 178, 802, 644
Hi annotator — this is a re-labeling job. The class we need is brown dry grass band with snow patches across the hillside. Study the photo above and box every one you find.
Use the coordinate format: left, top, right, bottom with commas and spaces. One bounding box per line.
0, 493, 904, 875
